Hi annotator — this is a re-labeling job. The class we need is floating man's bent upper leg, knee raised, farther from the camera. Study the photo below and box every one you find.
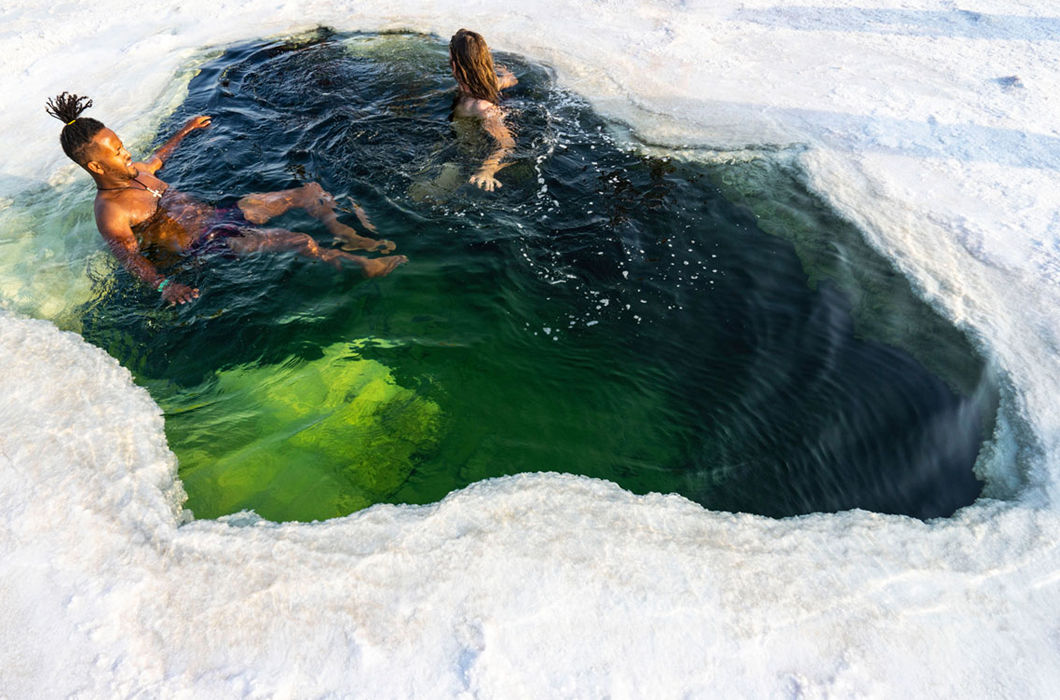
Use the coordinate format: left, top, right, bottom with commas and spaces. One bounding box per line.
236, 182, 396, 252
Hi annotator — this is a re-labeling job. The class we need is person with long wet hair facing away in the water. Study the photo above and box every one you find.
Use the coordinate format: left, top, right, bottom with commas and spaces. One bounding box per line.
449, 29, 518, 192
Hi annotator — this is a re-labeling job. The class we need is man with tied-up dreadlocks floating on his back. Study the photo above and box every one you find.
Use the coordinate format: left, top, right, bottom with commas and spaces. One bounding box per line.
46, 92, 407, 304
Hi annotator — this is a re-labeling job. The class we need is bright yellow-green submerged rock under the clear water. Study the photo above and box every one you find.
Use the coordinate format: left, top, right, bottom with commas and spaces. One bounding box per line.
171, 343, 441, 520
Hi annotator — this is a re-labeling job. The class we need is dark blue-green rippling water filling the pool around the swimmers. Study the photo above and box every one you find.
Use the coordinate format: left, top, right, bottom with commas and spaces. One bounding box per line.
84, 30, 994, 520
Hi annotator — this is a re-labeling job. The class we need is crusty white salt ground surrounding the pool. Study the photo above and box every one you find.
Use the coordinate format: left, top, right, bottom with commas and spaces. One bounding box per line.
0, 0, 1060, 697
